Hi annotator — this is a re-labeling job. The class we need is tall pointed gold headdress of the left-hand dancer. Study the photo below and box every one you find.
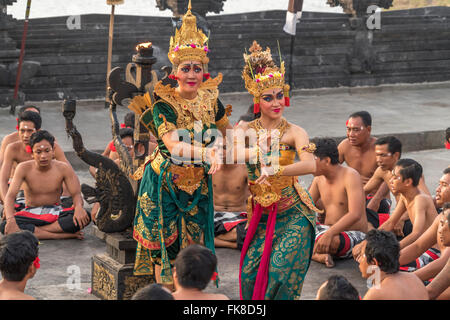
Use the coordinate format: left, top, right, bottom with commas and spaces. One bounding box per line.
168, 0, 209, 65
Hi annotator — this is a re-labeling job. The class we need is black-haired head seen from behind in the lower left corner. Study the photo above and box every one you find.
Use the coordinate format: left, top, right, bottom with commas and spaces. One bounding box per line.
0, 231, 39, 282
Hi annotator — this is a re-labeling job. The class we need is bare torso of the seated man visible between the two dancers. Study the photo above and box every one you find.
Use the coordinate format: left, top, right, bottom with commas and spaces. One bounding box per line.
212, 164, 249, 212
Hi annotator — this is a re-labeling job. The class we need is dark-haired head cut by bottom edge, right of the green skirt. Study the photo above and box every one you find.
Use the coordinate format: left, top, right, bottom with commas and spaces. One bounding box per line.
316, 275, 359, 300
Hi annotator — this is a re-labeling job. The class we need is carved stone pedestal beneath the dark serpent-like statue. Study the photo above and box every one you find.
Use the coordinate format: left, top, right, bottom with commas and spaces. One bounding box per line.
91, 228, 155, 300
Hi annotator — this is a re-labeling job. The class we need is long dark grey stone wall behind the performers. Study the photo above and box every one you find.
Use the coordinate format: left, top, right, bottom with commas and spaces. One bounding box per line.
4, 7, 450, 101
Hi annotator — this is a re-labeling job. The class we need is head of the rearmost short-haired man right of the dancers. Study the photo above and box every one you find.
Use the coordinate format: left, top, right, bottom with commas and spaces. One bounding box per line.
346, 111, 372, 146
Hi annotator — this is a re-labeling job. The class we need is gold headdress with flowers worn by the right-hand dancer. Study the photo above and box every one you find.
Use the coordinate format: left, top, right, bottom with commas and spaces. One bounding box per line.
242, 41, 290, 113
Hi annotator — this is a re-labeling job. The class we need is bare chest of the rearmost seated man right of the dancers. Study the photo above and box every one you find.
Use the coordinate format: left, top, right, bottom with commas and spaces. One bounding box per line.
338, 137, 377, 184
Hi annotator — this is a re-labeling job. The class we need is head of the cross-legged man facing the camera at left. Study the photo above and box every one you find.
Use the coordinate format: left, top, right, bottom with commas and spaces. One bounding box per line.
30, 130, 55, 167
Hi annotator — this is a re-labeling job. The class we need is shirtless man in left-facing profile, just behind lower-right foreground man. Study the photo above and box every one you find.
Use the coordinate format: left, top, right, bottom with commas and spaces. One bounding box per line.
353, 159, 437, 259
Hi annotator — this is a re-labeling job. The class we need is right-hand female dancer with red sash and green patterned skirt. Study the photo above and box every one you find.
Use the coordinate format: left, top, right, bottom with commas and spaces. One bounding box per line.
240, 41, 318, 300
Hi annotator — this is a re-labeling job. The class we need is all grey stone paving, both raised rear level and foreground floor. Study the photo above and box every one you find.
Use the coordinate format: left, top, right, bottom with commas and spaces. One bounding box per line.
0, 84, 450, 300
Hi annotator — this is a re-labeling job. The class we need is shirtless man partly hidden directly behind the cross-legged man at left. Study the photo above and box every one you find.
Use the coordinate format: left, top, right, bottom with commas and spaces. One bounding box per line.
0, 111, 70, 204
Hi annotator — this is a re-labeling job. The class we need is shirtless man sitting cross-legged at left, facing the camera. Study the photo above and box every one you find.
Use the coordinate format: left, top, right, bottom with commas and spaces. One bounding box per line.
0, 130, 90, 239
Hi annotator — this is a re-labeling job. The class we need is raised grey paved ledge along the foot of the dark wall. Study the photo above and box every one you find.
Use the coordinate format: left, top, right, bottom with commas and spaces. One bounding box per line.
0, 82, 450, 152
